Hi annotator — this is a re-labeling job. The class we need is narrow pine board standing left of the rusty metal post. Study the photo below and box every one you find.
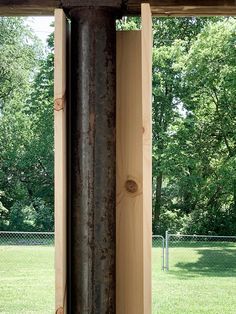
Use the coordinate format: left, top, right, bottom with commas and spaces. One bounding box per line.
54, 9, 67, 314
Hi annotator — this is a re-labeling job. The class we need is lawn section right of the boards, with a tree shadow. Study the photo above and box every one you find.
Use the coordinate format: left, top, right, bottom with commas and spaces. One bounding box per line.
152, 243, 236, 314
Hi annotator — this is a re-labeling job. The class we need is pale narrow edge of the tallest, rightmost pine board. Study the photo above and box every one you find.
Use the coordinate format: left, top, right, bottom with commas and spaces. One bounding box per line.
141, 4, 153, 313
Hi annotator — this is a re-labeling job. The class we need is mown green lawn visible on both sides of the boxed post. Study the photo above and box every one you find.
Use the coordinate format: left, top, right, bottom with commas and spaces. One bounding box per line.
0, 243, 236, 314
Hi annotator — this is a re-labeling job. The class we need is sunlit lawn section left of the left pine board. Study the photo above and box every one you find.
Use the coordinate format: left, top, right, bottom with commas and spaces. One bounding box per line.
0, 246, 54, 314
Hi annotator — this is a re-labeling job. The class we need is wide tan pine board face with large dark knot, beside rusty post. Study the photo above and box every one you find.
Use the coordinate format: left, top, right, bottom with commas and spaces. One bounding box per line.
116, 32, 143, 314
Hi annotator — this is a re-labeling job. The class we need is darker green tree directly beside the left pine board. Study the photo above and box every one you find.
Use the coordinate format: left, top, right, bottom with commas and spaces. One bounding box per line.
28, 34, 54, 231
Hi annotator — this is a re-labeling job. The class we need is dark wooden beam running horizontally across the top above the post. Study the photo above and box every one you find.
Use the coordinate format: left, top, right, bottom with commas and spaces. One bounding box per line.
0, 0, 236, 16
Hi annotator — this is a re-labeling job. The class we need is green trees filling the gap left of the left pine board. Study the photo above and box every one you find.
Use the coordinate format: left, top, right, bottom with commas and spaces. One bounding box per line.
0, 18, 54, 231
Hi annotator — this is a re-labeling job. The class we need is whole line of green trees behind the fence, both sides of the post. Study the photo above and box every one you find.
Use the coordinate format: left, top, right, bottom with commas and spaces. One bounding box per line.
0, 18, 236, 235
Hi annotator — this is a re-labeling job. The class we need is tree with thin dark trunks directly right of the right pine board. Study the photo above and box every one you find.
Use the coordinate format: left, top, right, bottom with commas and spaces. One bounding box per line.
153, 18, 218, 233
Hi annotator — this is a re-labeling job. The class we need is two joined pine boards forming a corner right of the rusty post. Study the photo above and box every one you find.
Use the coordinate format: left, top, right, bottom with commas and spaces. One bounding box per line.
116, 4, 152, 314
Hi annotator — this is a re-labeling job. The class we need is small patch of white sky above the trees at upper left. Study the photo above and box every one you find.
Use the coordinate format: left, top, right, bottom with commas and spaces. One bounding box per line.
27, 16, 54, 45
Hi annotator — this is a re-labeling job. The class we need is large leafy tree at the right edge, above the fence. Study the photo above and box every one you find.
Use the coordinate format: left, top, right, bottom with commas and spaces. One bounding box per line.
169, 18, 236, 234
